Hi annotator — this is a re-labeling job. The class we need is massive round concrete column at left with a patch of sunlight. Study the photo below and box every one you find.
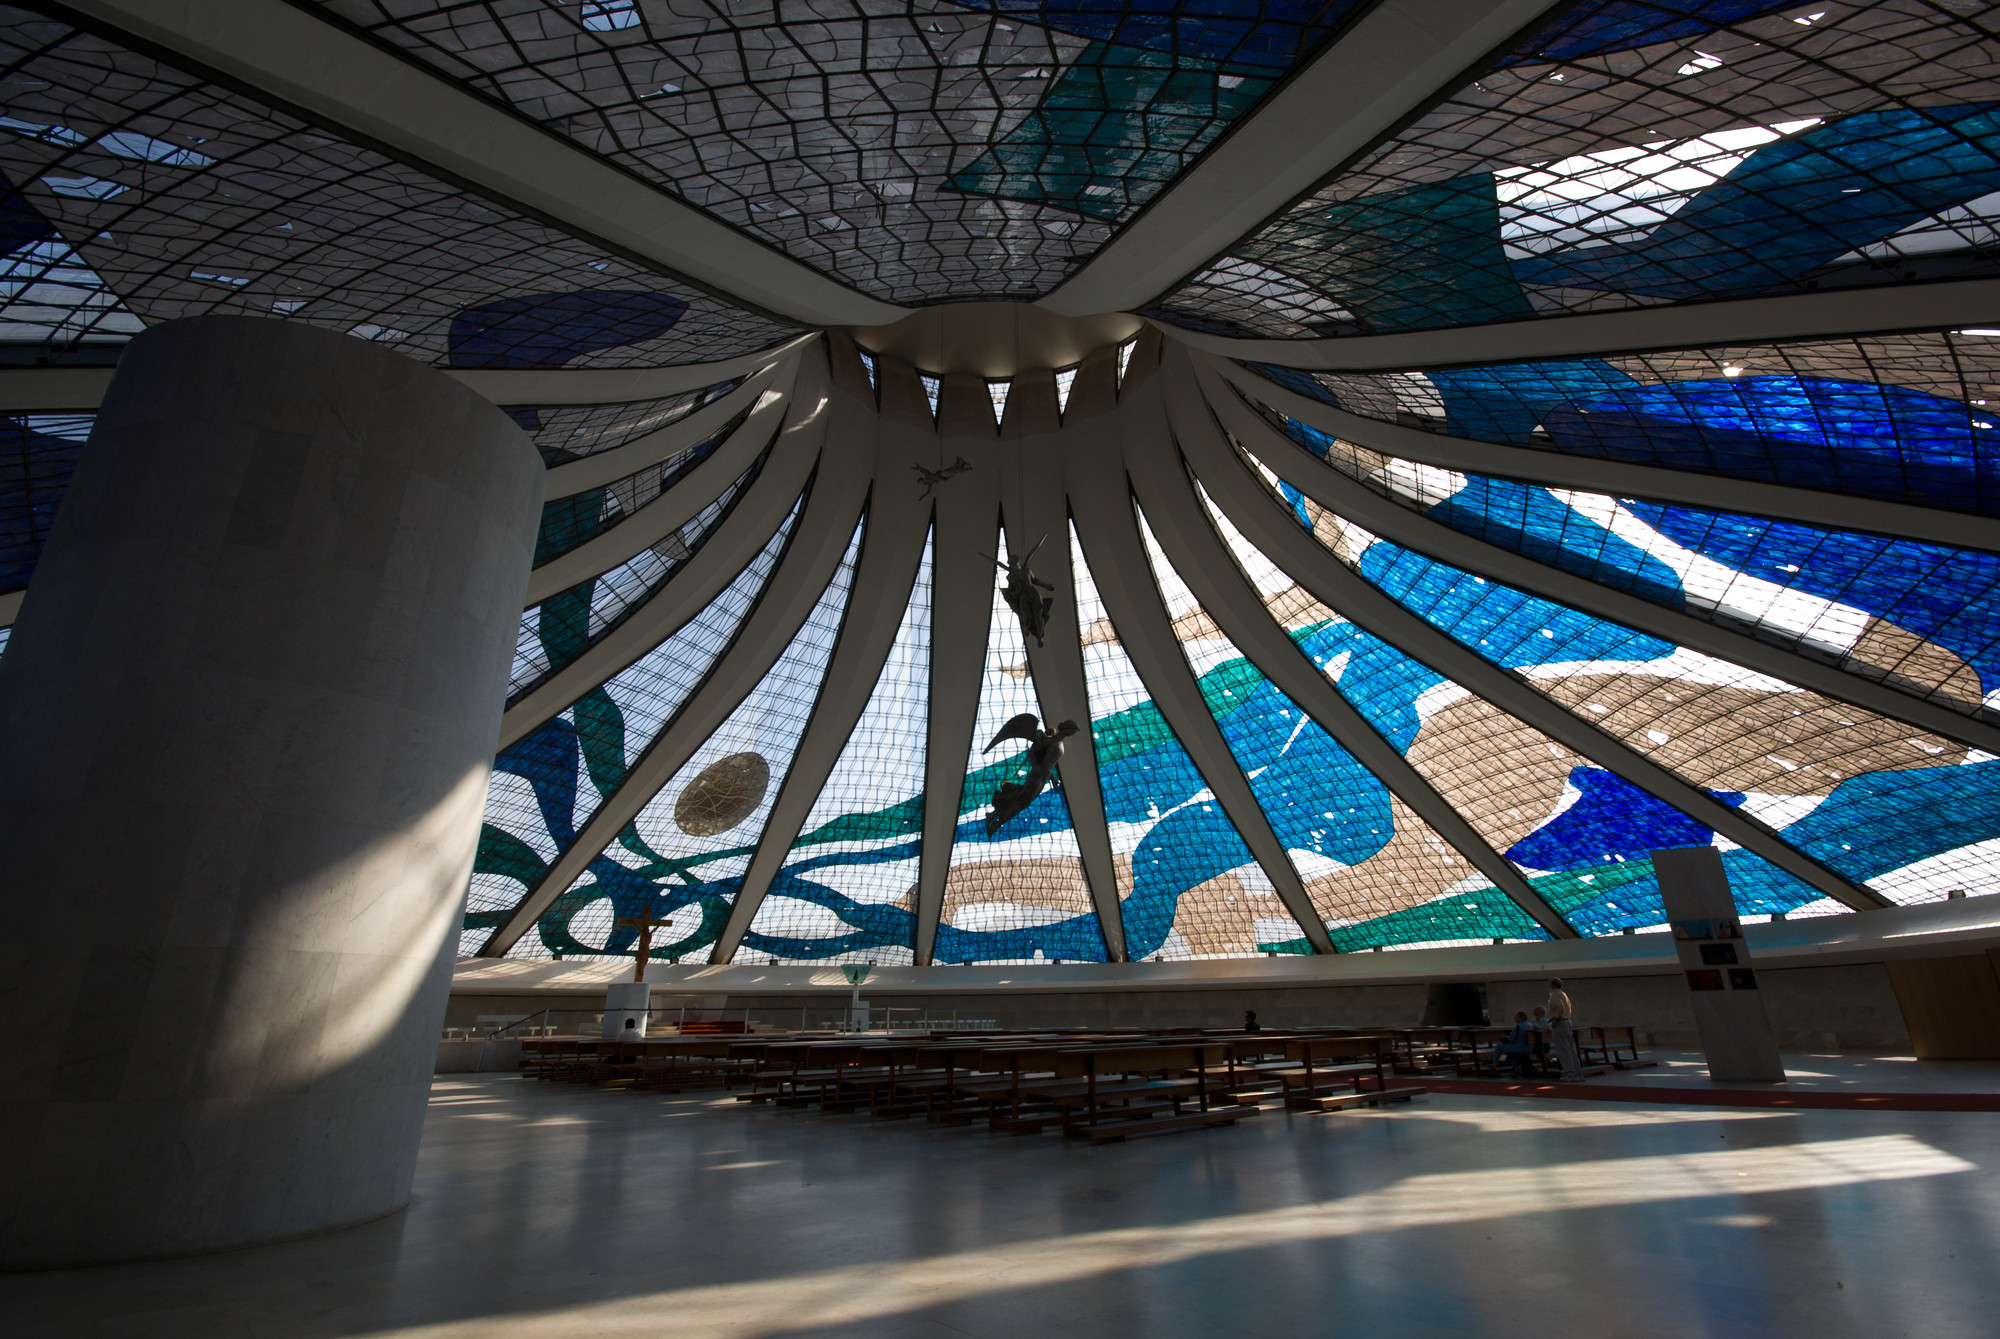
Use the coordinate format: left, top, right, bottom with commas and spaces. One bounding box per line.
0, 318, 544, 1269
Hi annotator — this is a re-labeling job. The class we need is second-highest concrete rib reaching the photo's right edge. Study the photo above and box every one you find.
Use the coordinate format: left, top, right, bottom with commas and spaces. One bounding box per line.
1194, 354, 2000, 552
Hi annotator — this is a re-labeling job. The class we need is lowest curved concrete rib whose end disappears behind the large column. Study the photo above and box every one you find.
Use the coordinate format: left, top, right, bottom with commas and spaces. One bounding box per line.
500, 378, 826, 749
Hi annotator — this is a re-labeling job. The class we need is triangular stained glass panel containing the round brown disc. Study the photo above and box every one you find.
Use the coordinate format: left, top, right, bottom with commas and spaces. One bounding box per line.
508, 520, 866, 959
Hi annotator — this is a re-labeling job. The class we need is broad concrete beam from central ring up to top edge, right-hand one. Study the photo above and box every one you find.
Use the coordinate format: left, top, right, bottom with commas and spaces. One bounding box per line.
1040, 0, 1566, 316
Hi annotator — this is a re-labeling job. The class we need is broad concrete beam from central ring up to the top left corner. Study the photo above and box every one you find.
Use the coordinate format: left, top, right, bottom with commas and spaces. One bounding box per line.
70, 0, 906, 326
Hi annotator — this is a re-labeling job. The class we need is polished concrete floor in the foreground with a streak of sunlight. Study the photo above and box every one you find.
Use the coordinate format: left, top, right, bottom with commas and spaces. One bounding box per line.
11, 1057, 2000, 1339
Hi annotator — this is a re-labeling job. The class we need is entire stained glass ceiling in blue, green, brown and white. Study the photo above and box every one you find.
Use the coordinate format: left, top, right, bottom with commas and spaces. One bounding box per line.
0, 0, 2000, 963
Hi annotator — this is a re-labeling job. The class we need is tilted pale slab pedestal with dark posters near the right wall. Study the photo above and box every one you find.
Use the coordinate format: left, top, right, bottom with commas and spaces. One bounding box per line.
1652, 845, 1784, 1083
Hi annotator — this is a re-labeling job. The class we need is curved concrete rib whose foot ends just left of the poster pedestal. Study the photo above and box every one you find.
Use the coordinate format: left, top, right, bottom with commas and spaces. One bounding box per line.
1126, 354, 1576, 939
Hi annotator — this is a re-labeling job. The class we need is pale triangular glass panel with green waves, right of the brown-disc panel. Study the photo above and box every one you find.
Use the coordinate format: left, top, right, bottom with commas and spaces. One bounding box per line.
732, 527, 932, 963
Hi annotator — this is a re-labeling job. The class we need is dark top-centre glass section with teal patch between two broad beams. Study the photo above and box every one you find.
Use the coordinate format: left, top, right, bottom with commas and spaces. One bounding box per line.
322, 0, 1362, 302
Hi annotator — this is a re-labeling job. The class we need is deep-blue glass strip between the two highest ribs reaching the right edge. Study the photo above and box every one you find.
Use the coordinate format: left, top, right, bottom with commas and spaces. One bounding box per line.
1256, 332, 2000, 516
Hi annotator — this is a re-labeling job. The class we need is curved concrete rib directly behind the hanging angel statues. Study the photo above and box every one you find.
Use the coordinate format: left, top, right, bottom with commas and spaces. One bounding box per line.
1016, 348, 1128, 963
